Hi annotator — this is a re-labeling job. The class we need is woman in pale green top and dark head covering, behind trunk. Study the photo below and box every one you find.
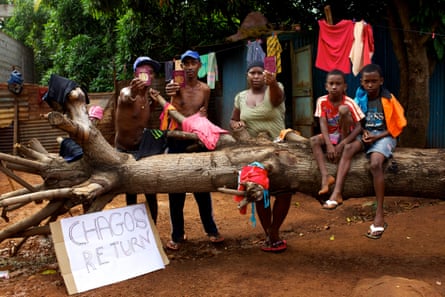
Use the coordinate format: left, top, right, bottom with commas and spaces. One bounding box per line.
230, 61, 292, 252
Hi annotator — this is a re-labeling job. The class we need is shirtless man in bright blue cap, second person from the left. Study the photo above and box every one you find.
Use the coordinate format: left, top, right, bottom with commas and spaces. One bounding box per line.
165, 50, 224, 250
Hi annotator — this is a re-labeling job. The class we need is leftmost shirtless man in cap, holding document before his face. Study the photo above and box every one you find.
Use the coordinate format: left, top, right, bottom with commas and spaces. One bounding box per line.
114, 56, 161, 223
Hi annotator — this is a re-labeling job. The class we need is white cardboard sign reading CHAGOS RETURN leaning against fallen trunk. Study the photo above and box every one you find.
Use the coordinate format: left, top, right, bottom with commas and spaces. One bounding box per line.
50, 203, 168, 295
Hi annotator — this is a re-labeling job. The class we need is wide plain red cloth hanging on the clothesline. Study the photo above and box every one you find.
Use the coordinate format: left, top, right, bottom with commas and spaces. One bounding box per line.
315, 20, 354, 74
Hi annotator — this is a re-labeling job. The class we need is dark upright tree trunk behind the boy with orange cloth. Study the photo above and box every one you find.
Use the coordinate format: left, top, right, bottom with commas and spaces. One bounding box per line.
388, 0, 434, 148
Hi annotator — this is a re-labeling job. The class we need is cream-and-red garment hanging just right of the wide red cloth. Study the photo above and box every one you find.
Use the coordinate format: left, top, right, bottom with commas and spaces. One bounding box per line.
349, 20, 374, 76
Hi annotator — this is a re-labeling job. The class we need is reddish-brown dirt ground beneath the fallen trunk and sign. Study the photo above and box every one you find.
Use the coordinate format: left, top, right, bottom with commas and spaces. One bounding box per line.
0, 173, 445, 297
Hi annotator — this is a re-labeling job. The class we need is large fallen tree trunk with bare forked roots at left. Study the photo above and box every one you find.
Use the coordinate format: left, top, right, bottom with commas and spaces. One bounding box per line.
0, 88, 445, 242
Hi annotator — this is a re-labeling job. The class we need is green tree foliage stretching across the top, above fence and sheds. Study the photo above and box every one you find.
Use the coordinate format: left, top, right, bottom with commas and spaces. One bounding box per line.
4, 0, 445, 91
